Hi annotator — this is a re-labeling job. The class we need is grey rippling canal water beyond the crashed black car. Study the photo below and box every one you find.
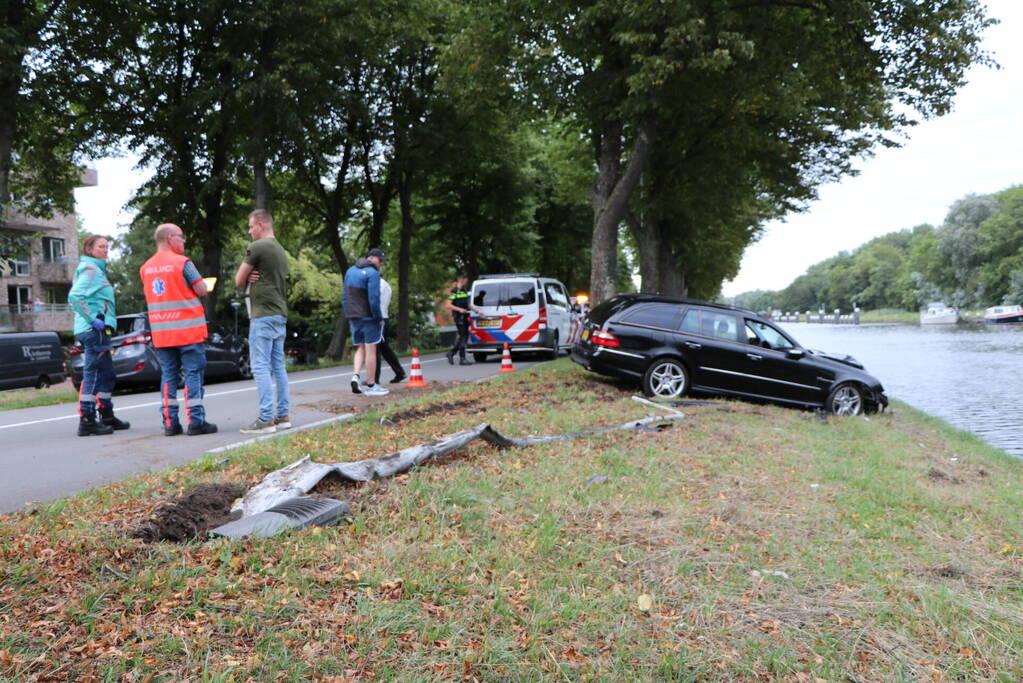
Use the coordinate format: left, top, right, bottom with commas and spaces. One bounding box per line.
782, 323, 1023, 456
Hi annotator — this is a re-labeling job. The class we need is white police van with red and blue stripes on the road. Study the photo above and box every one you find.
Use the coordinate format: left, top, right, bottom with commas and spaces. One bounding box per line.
468, 273, 580, 362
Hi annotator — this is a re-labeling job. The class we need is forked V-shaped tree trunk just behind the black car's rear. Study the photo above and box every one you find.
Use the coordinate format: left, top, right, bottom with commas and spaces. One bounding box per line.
589, 121, 654, 304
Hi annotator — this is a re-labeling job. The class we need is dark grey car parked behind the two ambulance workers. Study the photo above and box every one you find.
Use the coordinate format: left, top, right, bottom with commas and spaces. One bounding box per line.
70, 313, 252, 389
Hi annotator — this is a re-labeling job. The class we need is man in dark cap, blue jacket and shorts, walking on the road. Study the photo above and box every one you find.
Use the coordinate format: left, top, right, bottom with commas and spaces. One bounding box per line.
341, 248, 390, 396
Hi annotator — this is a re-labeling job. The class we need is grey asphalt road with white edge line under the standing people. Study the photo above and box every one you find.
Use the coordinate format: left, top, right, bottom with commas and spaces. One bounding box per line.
0, 354, 537, 513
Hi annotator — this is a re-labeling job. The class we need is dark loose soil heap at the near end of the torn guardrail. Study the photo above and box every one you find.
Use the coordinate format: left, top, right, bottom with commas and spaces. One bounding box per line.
130, 484, 246, 543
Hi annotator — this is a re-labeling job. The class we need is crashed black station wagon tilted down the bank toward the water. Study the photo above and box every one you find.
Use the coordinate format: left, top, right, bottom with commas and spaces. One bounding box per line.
572, 294, 888, 415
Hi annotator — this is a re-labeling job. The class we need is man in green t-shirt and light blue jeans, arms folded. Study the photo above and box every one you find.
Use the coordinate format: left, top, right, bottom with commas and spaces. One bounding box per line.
234, 209, 292, 434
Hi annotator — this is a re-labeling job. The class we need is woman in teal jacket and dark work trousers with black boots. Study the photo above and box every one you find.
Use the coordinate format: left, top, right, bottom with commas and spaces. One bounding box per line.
68, 235, 130, 437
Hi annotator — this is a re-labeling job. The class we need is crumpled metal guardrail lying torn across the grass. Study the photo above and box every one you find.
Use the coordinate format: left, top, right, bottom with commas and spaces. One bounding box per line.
212, 400, 684, 536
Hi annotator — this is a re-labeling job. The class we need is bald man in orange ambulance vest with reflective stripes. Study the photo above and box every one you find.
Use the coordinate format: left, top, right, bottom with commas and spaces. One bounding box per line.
138, 223, 217, 437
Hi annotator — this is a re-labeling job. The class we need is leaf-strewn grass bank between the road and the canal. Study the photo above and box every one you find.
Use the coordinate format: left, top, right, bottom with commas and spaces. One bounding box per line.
0, 359, 1023, 681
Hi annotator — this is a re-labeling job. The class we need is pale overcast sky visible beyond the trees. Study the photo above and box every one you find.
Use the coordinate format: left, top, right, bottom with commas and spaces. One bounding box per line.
75, 0, 1023, 295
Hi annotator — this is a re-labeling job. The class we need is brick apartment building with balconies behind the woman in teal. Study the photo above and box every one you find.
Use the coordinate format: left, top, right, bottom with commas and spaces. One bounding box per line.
0, 169, 96, 332
